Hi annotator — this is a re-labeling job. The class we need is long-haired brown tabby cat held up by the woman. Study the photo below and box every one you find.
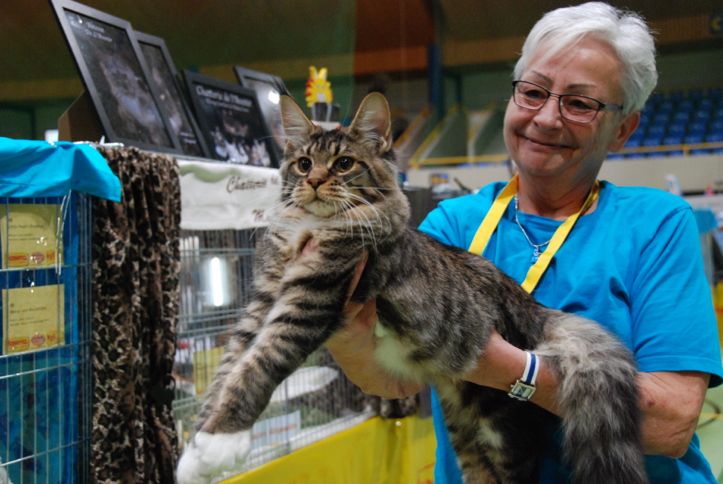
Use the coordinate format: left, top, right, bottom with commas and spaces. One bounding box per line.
178, 93, 647, 484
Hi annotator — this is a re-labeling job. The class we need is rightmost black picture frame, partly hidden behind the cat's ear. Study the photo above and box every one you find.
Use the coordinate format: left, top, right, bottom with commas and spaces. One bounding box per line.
234, 66, 289, 157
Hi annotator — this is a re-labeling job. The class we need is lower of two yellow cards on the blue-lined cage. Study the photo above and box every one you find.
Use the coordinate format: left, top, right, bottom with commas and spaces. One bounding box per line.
2, 284, 65, 354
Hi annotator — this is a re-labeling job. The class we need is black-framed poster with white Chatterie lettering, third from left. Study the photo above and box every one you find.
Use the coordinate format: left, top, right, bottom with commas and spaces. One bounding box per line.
183, 71, 279, 167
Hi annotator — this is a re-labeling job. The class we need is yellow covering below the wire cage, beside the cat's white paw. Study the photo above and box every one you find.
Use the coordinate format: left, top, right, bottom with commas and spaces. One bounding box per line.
223, 417, 436, 484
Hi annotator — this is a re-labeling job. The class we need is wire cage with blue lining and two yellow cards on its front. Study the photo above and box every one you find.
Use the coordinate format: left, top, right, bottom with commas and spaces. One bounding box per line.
0, 193, 92, 484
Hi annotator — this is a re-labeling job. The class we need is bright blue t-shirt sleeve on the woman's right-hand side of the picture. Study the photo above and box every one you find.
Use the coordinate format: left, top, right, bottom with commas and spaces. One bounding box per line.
630, 207, 723, 386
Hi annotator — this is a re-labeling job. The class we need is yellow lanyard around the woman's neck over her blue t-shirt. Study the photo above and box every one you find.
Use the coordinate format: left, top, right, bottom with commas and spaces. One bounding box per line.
467, 175, 600, 293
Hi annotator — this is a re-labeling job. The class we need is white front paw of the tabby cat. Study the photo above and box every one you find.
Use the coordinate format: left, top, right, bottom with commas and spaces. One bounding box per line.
176, 430, 251, 484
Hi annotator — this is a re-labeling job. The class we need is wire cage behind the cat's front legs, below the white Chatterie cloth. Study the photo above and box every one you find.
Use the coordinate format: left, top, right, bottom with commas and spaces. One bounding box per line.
173, 230, 374, 476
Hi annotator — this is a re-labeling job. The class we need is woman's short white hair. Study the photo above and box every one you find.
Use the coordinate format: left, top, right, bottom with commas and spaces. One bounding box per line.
514, 2, 658, 114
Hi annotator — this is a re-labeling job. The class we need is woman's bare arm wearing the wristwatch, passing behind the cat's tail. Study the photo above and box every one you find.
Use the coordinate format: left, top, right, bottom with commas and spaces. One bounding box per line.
464, 333, 710, 458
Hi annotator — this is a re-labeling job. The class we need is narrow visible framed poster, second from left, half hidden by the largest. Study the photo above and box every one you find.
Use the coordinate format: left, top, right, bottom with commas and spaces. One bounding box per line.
134, 30, 209, 157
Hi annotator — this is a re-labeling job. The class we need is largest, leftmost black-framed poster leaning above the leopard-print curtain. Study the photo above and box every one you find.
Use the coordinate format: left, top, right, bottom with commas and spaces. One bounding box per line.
51, 0, 179, 153
